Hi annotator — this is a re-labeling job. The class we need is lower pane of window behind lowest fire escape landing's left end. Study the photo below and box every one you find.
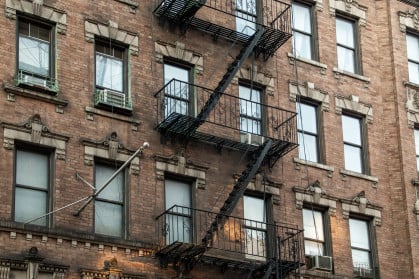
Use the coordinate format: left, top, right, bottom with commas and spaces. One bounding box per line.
166, 214, 192, 244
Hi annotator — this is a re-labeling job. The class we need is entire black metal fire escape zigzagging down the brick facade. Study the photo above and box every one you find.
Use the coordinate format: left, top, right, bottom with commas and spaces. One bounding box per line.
154, 0, 302, 278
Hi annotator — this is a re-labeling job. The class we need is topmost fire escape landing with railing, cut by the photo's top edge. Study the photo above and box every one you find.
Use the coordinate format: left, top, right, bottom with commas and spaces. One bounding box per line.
154, 0, 292, 60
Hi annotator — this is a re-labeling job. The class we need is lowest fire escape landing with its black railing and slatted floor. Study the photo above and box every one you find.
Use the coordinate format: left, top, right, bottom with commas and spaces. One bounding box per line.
156, 205, 304, 278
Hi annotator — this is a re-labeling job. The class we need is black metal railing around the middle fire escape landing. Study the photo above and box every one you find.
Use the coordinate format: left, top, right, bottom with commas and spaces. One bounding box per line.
155, 79, 297, 148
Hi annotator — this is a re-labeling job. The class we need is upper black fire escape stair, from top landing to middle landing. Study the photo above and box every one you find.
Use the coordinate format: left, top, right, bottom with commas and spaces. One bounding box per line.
186, 26, 265, 136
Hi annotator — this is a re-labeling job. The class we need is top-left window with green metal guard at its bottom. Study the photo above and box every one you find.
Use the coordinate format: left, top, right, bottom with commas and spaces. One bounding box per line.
17, 17, 58, 91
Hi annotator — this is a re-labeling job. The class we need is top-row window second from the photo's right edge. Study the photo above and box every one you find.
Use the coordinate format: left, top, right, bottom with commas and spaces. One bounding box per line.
336, 17, 360, 73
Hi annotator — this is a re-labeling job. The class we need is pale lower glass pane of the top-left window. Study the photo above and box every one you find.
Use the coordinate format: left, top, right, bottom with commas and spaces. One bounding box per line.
19, 35, 50, 76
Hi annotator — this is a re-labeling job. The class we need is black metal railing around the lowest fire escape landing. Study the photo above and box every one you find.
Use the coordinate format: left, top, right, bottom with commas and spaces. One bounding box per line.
156, 205, 303, 266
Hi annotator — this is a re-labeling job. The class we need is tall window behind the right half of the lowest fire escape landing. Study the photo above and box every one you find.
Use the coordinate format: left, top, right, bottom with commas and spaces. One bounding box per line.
243, 195, 267, 258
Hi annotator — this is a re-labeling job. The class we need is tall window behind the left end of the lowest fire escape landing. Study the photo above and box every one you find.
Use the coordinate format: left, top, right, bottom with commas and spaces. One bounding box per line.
165, 179, 192, 244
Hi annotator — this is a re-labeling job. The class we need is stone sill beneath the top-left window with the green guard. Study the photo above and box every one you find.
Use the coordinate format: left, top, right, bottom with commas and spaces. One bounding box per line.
3, 83, 68, 113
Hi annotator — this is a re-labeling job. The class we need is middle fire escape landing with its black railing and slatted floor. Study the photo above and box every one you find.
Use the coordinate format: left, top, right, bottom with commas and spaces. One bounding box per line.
155, 79, 298, 166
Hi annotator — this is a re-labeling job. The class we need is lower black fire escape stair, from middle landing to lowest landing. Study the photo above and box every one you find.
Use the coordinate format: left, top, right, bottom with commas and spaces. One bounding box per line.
202, 140, 272, 245
